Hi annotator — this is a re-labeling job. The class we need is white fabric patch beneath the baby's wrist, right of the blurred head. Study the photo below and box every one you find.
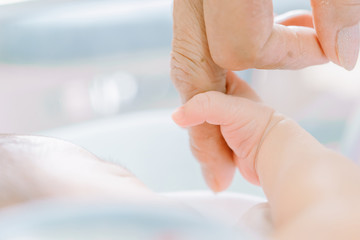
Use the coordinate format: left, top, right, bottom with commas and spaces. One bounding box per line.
162, 191, 272, 237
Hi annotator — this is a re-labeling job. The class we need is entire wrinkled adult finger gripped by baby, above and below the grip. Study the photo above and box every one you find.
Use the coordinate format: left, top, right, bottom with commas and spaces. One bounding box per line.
171, 0, 235, 192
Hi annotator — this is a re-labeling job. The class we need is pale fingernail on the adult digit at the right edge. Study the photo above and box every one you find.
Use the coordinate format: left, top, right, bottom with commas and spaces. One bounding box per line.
336, 24, 360, 71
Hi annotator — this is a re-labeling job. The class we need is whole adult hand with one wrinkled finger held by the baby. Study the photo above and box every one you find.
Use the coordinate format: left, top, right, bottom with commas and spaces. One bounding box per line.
171, 0, 360, 192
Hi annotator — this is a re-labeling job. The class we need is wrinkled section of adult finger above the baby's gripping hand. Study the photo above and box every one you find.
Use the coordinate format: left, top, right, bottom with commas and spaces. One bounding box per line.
171, 0, 226, 102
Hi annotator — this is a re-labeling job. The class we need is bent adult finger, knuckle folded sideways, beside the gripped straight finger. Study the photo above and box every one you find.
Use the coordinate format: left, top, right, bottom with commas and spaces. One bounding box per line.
204, 0, 327, 70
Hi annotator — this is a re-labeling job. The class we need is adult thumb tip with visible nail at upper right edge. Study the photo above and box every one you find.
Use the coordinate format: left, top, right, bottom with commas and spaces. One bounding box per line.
311, 0, 360, 70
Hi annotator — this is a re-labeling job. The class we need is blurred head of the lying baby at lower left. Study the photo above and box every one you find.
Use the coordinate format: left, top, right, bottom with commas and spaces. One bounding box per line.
0, 135, 156, 207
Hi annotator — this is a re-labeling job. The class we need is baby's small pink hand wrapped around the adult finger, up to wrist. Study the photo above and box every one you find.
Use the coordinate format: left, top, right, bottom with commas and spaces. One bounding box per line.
173, 72, 274, 185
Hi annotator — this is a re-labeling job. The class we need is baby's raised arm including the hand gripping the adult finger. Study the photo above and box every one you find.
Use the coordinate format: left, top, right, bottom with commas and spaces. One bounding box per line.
173, 77, 360, 240
